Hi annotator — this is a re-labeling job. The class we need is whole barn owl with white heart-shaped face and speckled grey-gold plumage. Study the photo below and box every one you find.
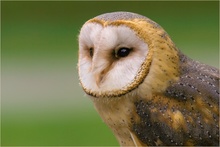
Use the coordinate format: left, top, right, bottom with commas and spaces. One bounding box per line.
78, 12, 219, 146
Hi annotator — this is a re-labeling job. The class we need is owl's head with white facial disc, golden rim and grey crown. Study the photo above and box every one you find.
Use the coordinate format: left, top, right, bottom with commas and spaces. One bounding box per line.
78, 12, 178, 98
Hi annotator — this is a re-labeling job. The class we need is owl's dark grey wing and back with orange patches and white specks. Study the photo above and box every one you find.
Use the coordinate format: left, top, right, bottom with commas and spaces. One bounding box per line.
132, 53, 219, 146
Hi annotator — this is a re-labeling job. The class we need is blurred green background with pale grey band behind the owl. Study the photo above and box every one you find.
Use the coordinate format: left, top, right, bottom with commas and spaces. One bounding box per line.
1, 1, 219, 146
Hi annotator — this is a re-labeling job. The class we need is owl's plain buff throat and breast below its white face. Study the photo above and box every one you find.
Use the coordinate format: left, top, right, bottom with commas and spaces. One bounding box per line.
93, 97, 142, 146
